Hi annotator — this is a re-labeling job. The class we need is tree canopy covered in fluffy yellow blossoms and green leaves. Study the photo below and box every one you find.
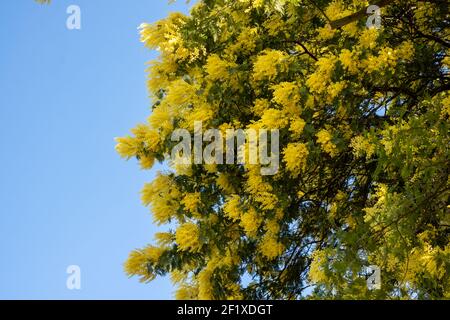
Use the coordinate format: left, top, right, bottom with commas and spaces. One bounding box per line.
116, 0, 450, 299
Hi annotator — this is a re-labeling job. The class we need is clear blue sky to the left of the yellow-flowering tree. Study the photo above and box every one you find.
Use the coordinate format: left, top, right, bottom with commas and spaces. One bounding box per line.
0, 0, 192, 299
